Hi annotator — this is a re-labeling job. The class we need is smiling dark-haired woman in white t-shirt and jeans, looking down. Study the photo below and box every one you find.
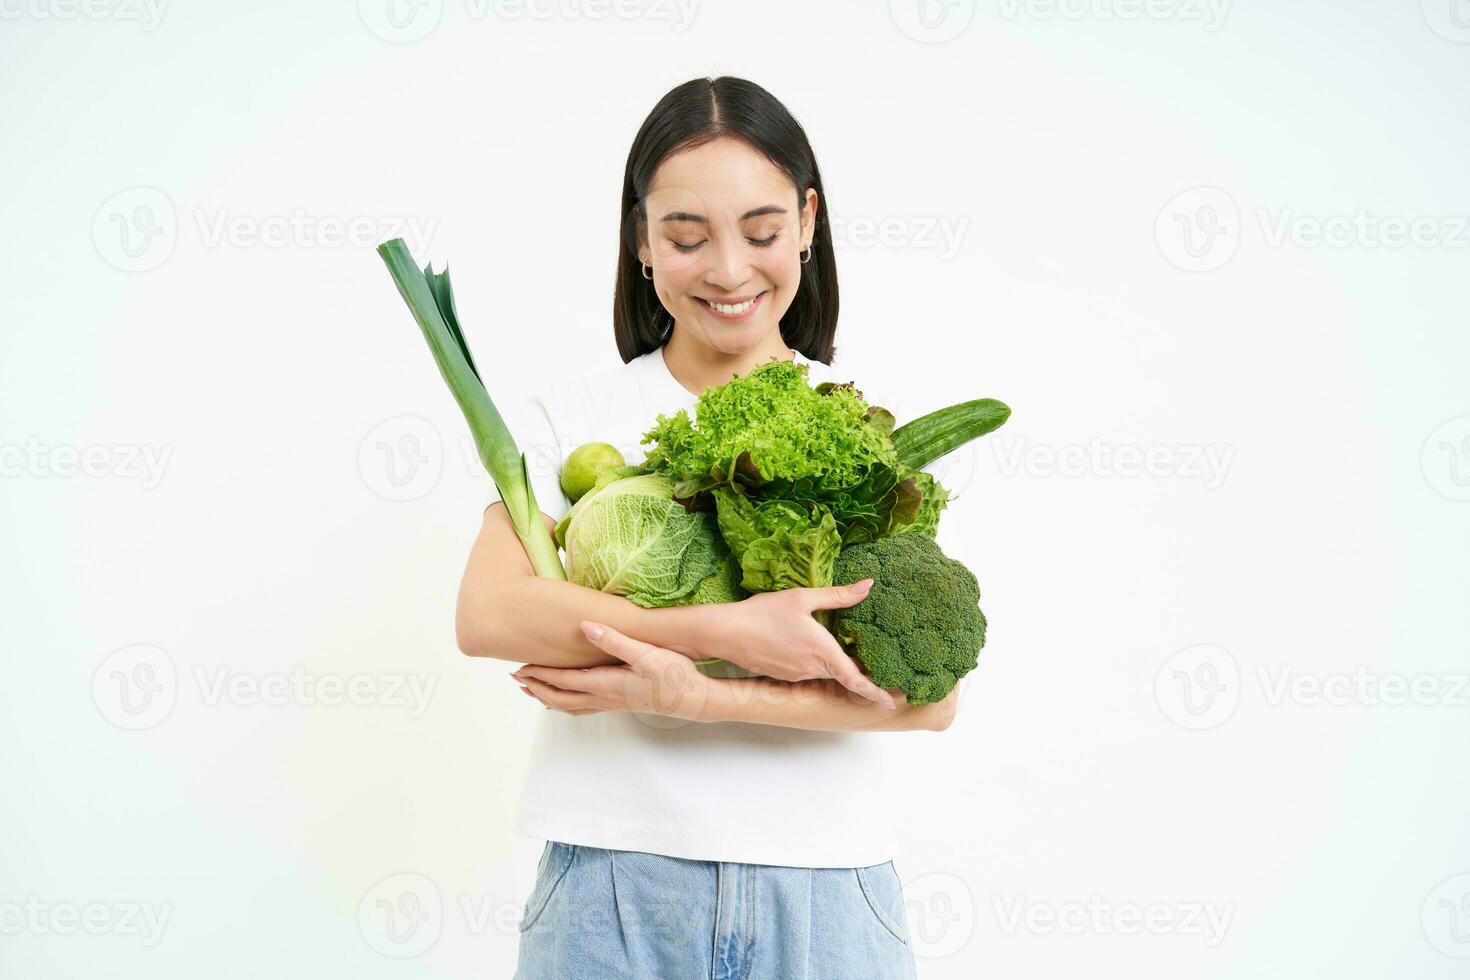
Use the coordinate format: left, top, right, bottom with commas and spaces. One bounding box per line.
470, 78, 923, 980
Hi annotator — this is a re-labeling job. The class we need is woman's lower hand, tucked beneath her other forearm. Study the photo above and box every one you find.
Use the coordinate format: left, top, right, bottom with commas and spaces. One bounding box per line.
510, 623, 716, 721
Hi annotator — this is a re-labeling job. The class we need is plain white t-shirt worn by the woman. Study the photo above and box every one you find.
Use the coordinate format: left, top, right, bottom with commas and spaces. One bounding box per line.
507, 348, 914, 867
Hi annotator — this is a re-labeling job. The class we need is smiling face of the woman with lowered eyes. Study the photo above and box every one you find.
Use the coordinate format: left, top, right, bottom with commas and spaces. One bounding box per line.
639, 138, 817, 354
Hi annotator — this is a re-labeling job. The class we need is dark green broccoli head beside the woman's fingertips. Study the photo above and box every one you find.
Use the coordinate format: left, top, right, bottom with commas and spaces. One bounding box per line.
831, 533, 985, 704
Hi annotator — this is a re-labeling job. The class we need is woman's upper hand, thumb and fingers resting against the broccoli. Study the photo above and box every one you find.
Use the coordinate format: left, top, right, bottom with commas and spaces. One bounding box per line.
692, 579, 897, 708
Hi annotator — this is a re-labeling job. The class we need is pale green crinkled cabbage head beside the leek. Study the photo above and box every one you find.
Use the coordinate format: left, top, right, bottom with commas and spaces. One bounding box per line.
556, 473, 748, 608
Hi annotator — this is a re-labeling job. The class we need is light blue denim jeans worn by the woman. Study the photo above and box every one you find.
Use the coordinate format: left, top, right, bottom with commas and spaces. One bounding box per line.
515, 840, 916, 980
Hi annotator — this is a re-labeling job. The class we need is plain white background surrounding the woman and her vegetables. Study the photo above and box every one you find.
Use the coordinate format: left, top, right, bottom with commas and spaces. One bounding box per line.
0, 0, 1470, 980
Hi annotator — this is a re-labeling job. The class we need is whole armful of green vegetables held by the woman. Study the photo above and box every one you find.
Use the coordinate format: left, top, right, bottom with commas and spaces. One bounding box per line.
379, 239, 1010, 704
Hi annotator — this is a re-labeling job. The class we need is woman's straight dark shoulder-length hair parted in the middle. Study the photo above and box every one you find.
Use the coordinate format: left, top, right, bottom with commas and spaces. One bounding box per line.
613, 75, 838, 364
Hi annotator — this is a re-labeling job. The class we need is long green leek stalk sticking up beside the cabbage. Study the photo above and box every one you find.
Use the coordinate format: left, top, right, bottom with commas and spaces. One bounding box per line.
378, 238, 566, 582
